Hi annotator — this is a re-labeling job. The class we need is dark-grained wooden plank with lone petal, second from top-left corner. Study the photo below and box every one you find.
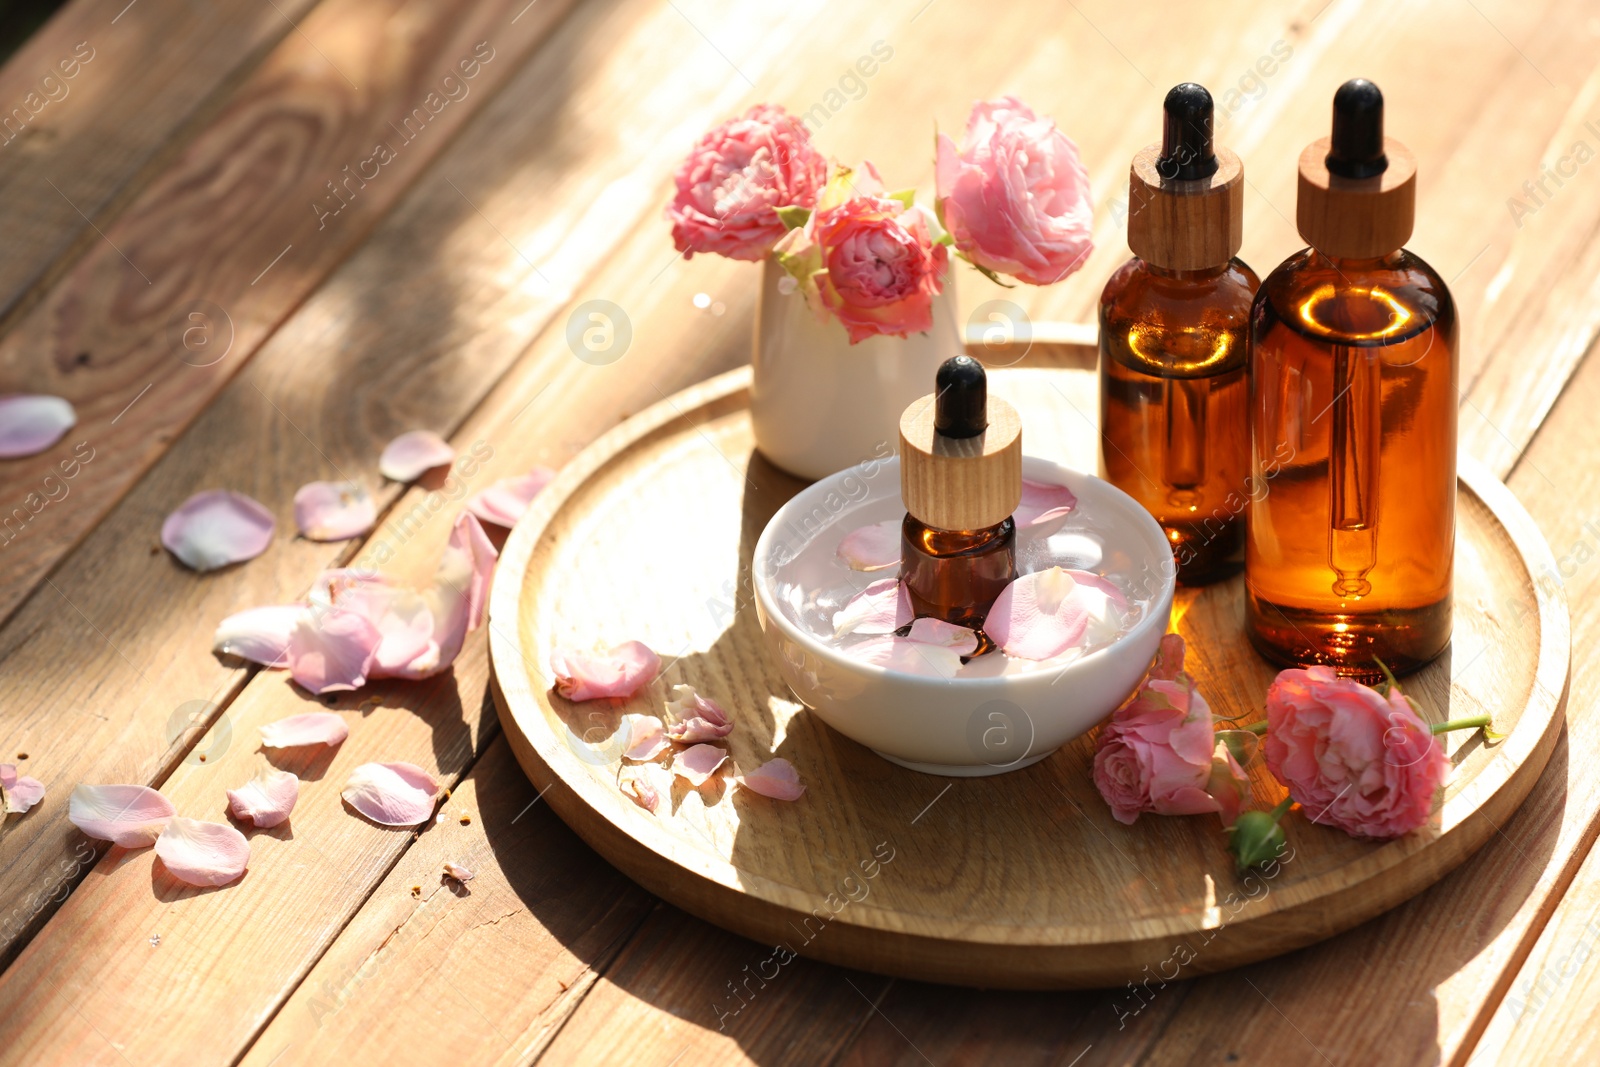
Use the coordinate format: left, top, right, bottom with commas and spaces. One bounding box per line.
0, 0, 571, 630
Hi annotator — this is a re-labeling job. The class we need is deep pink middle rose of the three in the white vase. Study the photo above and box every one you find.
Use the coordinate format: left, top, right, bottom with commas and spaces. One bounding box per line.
776, 163, 949, 344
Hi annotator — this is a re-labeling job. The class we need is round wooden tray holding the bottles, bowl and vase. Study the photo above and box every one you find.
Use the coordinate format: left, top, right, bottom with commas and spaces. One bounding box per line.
490, 370, 1568, 991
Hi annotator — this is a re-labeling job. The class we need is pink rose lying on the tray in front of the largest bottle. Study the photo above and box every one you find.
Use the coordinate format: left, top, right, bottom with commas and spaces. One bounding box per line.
1262, 667, 1450, 840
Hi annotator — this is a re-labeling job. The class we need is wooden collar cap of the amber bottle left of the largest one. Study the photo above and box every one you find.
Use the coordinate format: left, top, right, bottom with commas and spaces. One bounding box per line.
1128, 144, 1245, 270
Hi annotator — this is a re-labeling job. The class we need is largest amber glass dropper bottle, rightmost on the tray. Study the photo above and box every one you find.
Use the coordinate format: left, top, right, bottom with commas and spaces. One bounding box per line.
1245, 78, 1458, 680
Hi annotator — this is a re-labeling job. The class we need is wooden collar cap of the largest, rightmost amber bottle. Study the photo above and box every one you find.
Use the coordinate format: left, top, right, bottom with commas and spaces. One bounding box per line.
1294, 138, 1416, 259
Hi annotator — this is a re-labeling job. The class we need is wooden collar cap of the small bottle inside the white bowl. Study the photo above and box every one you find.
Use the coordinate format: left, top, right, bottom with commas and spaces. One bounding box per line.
901, 394, 1022, 530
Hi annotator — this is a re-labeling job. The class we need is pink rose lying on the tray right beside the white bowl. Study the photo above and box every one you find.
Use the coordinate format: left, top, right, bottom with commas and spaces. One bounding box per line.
1094, 633, 1250, 824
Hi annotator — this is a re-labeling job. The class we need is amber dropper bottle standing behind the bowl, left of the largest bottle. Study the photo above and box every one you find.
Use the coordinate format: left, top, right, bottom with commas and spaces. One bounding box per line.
1099, 82, 1259, 584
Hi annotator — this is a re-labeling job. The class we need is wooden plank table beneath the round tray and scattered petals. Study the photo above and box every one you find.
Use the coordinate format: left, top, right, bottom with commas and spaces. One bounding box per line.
0, 0, 1600, 1067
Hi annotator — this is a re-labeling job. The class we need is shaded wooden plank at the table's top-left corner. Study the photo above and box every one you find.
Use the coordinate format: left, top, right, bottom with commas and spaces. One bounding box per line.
0, 0, 318, 322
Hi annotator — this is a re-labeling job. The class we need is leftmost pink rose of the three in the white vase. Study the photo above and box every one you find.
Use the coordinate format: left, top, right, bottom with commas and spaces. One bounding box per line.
667, 104, 827, 259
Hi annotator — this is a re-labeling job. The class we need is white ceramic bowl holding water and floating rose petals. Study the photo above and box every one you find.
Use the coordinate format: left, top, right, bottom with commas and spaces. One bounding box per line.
752, 458, 1174, 776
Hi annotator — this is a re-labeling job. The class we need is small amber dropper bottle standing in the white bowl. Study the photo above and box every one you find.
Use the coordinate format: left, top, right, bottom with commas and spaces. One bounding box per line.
901, 355, 1022, 653
